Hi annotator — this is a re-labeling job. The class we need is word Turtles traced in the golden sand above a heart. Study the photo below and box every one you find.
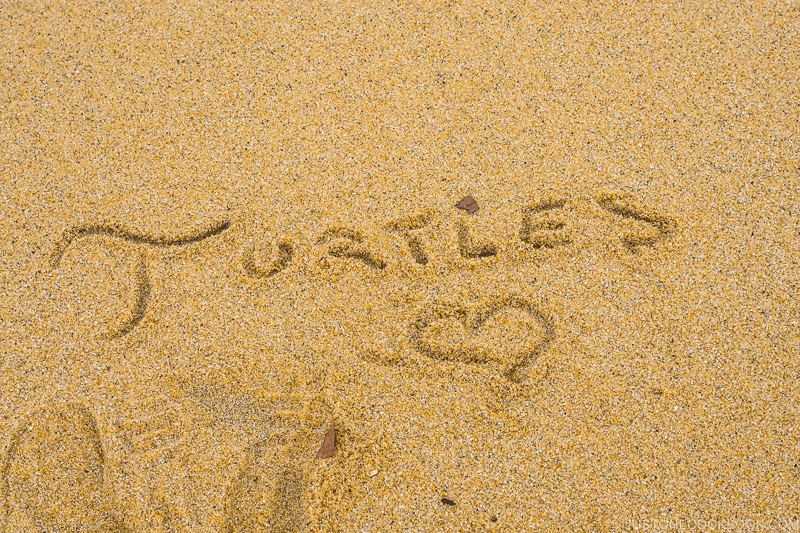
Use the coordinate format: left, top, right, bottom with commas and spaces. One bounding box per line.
50, 193, 676, 338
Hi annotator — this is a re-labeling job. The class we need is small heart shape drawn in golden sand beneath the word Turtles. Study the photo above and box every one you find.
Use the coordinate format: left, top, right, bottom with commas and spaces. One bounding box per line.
410, 296, 554, 381
